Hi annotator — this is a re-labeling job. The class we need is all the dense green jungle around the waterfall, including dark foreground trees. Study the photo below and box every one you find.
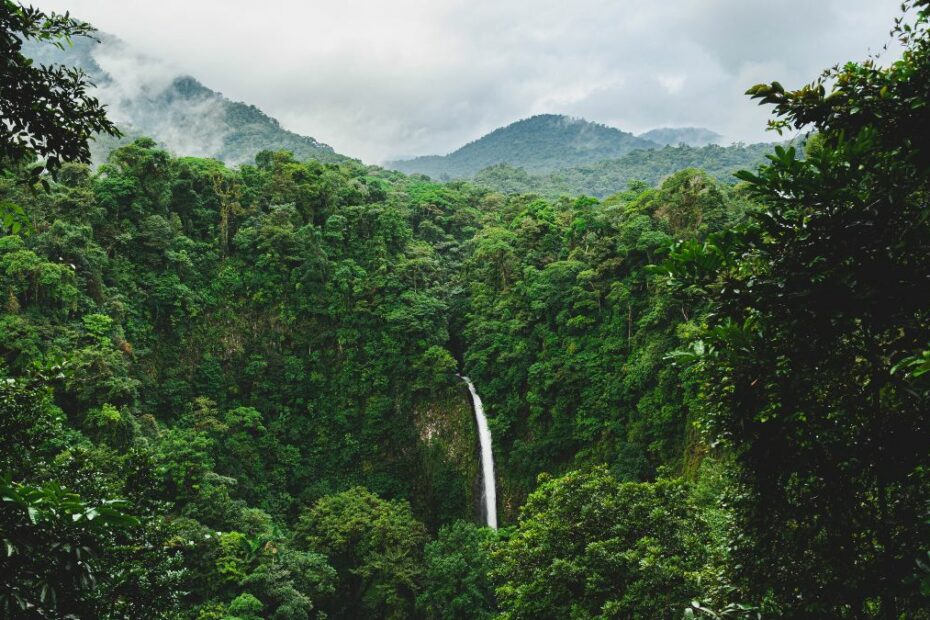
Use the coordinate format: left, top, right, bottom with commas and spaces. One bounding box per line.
0, 0, 930, 620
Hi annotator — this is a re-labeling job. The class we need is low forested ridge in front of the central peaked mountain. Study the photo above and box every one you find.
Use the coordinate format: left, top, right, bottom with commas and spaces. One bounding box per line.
473, 144, 773, 198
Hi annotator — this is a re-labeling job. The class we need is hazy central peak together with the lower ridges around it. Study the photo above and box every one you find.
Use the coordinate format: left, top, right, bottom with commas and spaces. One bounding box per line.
386, 114, 772, 198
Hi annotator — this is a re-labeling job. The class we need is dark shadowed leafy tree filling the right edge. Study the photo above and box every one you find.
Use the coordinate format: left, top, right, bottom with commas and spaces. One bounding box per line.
667, 1, 930, 618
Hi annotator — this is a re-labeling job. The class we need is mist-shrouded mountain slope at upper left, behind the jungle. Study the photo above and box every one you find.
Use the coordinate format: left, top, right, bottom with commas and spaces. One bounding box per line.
24, 33, 348, 165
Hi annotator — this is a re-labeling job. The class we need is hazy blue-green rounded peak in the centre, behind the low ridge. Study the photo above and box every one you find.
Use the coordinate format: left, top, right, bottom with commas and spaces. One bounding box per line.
386, 114, 659, 179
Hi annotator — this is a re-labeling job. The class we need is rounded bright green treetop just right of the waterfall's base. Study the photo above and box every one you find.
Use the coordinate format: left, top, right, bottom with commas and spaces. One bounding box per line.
493, 467, 707, 619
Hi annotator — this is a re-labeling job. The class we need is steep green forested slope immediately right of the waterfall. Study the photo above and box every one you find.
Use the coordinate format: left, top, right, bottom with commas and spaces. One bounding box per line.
464, 171, 748, 515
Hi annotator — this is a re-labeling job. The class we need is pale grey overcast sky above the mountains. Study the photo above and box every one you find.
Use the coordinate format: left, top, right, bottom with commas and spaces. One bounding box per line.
33, 0, 900, 163
